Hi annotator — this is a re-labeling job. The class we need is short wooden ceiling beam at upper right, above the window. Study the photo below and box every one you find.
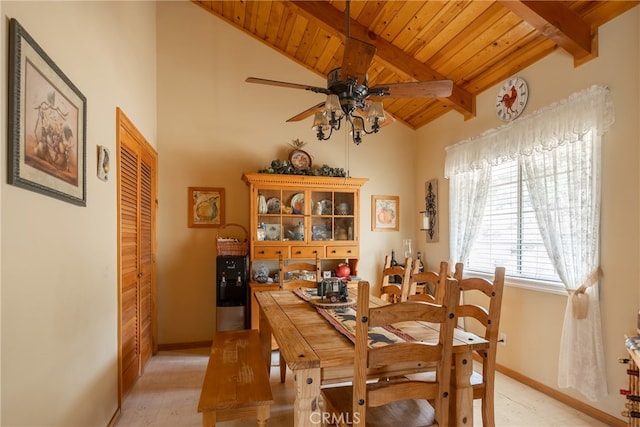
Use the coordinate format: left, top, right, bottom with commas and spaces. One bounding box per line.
499, 0, 598, 66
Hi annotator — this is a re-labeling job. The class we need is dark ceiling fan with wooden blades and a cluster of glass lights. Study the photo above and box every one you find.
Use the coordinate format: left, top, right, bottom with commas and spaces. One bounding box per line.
246, 0, 453, 145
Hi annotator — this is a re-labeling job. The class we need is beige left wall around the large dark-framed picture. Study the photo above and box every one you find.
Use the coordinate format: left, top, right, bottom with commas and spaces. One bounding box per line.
0, 1, 157, 427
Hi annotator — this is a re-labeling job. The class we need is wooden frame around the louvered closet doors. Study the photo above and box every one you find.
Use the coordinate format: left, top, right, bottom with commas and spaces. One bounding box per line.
116, 107, 158, 412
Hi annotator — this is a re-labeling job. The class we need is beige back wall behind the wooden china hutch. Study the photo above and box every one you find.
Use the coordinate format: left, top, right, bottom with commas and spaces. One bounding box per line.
158, 2, 419, 343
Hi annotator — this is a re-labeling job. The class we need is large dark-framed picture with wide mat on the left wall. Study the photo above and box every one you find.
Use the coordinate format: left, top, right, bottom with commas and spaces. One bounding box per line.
7, 18, 87, 206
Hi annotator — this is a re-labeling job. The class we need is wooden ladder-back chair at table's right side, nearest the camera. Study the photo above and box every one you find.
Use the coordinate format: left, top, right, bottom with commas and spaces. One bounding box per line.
454, 263, 505, 427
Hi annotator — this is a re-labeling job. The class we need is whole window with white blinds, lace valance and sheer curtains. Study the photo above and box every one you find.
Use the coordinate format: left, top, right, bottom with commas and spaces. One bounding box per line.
445, 86, 614, 401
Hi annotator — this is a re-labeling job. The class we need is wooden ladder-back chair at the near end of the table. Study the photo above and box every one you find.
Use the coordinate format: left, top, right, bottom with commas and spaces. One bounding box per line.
322, 278, 459, 427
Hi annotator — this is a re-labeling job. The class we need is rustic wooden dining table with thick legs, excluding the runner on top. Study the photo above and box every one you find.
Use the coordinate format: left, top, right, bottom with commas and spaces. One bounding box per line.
255, 290, 489, 427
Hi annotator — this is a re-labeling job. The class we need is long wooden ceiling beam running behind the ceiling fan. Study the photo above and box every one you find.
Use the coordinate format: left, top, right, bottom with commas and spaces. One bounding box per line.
288, 0, 476, 120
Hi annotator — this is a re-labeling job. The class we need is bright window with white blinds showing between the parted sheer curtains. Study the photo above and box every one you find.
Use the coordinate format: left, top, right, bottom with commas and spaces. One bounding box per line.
465, 160, 560, 283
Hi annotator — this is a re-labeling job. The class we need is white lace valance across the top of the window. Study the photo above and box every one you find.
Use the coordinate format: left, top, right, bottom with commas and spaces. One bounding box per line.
444, 86, 614, 178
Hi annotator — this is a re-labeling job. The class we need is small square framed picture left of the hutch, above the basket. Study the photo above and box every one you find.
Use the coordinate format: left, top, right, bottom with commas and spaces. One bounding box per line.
188, 187, 225, 228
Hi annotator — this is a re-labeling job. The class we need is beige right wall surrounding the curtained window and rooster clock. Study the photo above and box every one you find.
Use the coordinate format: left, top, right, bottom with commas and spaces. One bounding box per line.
416, 8, 640, 422
